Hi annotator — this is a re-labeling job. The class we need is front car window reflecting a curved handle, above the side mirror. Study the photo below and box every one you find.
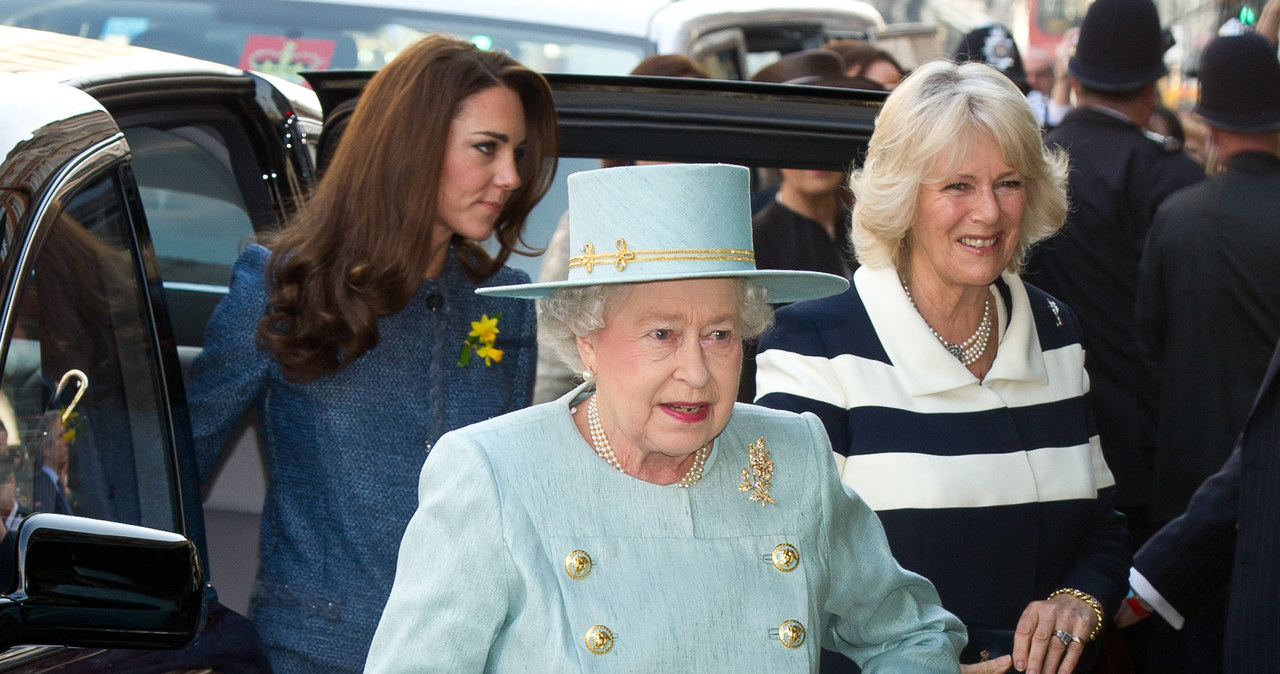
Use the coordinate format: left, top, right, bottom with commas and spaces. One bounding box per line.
0, 170, 180, 570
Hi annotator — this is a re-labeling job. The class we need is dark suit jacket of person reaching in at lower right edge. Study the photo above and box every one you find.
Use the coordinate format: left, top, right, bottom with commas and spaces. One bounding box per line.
1134, 340, 1280, 671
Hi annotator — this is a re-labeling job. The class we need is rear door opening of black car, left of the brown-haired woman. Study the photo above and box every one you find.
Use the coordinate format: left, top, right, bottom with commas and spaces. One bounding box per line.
77, 72, 315, 350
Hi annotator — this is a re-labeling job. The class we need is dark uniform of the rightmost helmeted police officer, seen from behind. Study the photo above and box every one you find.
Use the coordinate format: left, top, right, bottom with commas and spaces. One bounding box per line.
1138, 152, 1280, 523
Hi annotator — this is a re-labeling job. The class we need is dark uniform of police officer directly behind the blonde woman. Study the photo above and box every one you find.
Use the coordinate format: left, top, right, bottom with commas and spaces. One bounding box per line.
1025, 107, 1204, 541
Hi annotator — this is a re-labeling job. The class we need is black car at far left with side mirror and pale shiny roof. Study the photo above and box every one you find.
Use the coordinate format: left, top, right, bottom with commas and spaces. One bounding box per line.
0, 27, 319, 671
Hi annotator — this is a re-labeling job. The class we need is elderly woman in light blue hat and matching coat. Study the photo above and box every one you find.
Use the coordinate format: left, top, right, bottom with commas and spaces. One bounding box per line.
366, 165, 965, 673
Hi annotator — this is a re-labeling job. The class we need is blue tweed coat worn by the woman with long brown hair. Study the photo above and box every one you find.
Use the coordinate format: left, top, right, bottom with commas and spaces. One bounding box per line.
189, 246, 536, 673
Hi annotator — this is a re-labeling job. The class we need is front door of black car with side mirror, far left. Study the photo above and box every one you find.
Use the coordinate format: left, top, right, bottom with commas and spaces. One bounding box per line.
0, 74, 265, 671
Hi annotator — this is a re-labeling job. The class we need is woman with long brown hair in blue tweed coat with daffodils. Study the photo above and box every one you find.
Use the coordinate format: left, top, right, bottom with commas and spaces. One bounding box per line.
191, 36, 557, 671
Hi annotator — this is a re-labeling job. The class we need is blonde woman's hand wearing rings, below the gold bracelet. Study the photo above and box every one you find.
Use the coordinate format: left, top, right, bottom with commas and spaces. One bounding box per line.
1014, 595, 1098, 674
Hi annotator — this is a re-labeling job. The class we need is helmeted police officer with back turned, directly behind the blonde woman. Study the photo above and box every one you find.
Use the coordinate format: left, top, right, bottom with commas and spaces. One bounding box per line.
1025, 0, 1204, 542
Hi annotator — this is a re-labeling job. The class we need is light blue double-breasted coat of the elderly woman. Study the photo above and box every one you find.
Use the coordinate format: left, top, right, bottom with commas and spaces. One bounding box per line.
366, 391, 965, 673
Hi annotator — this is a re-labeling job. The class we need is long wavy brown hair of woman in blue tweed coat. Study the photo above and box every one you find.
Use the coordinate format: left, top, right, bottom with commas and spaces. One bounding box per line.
257, 35, 558, 382
